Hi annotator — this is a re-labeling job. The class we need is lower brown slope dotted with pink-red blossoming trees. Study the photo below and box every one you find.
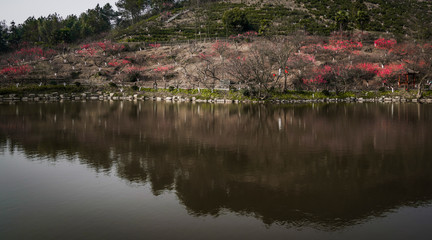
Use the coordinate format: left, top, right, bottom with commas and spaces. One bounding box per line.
0, 32, 432, 96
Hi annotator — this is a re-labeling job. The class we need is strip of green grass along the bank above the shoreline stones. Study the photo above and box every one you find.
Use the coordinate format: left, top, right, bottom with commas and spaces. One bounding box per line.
0, 85, 426, 101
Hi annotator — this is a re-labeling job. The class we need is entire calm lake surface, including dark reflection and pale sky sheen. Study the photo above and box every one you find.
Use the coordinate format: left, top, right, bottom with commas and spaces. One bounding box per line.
0, 102, 432, 240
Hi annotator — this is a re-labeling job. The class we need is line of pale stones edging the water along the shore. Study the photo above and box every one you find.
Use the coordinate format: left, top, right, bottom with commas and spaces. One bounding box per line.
0, 92, 432, 104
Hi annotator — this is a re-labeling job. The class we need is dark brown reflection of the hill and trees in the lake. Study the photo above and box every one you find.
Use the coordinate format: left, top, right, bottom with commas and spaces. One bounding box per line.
0, 102, 432, 227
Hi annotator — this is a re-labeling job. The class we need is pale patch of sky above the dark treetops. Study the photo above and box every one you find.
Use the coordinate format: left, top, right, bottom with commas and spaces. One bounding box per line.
0, 0, 118, 26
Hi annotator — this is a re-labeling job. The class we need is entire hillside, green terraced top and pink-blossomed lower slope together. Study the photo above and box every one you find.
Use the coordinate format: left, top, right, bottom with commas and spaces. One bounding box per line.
0, 0, 432, 98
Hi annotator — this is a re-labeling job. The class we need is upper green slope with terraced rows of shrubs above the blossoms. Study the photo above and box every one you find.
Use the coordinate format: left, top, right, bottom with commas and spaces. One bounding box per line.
112, 0, 432, 42
